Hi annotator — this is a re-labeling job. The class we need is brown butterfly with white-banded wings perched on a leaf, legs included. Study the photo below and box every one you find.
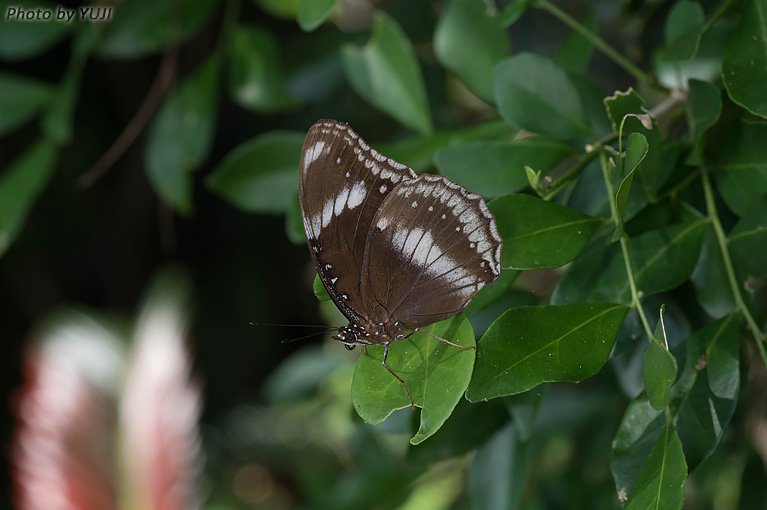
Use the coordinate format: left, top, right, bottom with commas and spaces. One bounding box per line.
299, 120, 503, 409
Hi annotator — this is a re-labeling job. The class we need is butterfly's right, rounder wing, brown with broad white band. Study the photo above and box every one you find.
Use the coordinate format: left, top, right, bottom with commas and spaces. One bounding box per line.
362, 174, 503, 329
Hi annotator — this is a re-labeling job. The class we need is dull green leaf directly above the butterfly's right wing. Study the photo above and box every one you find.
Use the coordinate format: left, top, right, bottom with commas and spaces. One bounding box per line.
434, 137, 572, 198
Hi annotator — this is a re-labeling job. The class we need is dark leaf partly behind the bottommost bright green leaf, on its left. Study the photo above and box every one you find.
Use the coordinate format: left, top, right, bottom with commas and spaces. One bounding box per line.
610, 395, 666, 501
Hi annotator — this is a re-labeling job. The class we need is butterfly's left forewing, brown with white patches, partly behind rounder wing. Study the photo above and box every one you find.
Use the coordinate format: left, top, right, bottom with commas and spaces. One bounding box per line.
299, 120, 416, 322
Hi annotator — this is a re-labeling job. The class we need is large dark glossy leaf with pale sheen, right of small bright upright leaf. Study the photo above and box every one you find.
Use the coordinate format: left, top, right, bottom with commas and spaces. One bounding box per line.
670, 313, 740, 470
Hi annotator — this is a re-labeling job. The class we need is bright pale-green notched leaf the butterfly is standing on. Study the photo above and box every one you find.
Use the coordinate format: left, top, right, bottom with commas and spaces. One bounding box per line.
352, 314, 475, 444
